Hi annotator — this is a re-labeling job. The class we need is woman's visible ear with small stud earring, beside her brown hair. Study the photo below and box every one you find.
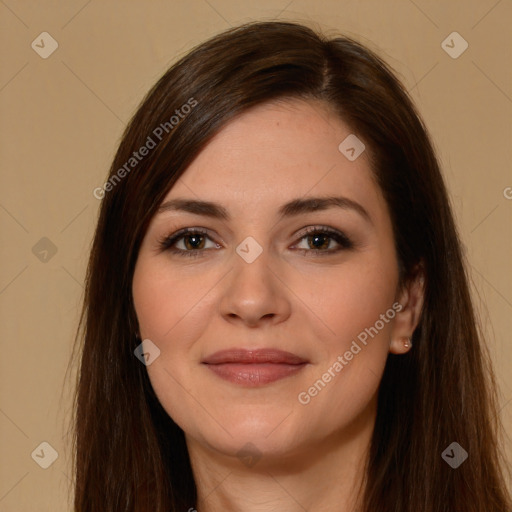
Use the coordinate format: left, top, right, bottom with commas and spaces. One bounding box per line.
389, 262, 425, 354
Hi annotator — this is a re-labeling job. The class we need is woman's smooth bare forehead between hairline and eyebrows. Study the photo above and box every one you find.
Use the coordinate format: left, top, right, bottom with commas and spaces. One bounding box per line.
158, 99, 382, 221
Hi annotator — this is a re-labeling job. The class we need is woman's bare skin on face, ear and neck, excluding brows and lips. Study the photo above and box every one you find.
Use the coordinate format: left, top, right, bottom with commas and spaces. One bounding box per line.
133, 100, 423, 512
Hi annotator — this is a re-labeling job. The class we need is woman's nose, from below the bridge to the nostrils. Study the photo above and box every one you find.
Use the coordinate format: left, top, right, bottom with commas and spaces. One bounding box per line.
220, 245, 291, 327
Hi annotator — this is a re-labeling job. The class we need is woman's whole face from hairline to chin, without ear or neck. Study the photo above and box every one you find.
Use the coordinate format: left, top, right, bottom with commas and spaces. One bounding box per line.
133, 100, 412, 466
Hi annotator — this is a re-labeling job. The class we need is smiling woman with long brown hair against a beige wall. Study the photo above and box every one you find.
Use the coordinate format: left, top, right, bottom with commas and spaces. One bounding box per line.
75, 22, 511, 512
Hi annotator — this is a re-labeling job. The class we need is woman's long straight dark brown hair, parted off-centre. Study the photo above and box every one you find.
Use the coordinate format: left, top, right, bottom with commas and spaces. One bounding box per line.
69, 22, 512, 512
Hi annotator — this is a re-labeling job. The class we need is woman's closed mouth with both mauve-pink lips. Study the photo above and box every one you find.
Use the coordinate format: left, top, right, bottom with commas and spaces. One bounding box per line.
201, 349, 309, 387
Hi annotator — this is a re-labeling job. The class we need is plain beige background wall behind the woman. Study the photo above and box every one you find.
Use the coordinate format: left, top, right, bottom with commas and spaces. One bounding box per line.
0, 0, 512, 512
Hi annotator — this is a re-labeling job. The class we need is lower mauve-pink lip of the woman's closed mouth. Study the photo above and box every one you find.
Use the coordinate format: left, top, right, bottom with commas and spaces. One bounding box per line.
206, 363, 306, 387
